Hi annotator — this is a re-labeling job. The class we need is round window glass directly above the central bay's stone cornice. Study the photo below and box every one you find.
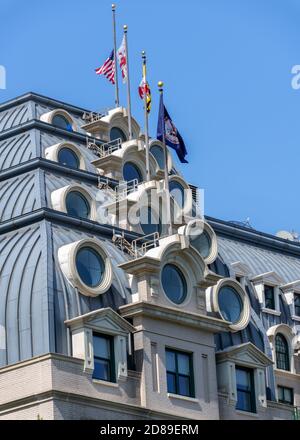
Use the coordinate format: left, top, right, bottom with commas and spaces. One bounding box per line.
161, 264, 187, 304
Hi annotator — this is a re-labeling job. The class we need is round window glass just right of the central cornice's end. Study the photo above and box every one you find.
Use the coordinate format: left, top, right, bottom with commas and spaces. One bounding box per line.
218, 286, 243, 324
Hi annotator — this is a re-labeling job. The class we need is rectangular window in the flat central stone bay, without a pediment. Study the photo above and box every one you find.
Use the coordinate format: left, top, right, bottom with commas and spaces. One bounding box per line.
166, 349, 195, 397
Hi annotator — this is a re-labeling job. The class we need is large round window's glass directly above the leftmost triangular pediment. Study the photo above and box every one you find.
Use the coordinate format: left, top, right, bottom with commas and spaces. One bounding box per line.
76, 247, 105, 288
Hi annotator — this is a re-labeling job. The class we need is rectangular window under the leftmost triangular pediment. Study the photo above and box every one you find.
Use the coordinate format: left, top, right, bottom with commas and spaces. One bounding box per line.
93, 334, 116, 382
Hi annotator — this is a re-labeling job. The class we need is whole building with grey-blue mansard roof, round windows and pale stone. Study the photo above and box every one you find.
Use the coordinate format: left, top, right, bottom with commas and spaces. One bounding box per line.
0, 93, 300, 420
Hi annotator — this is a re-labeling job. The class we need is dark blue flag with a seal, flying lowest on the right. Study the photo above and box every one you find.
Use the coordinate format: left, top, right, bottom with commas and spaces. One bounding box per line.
157, 94, 188, 163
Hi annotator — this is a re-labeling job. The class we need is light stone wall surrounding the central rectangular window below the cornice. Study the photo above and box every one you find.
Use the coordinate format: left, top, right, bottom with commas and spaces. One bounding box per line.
134, 317, 219, 420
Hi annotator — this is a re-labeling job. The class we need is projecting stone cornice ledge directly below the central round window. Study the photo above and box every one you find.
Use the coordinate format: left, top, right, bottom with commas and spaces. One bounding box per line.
119, 301, 229, 333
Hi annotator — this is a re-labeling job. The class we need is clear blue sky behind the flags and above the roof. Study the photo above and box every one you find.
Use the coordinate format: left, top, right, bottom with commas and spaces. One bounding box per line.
0, 0, 300, 233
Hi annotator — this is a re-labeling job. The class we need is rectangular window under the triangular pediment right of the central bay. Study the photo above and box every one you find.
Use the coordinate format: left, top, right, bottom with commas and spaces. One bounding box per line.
235, 367, 256, 412
